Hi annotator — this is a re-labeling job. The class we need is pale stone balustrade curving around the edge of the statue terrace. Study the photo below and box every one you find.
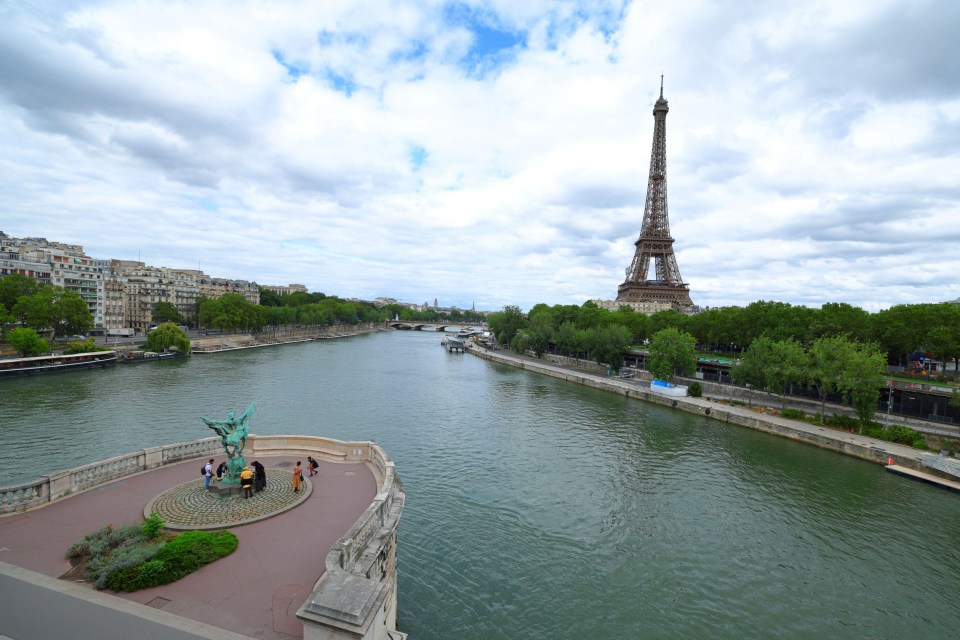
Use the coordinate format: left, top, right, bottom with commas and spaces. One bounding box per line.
0, 435, 406, 640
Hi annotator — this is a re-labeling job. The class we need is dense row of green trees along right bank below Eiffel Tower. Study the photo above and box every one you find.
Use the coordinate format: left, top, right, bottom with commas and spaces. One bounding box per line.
489, 300, 960, 425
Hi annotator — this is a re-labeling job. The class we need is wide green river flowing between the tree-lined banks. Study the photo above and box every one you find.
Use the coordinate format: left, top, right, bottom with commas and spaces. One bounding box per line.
0, 332, 960, 640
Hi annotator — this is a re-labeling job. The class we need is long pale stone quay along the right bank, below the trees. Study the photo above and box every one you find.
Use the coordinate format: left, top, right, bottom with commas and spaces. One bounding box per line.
468, 343, 960, 486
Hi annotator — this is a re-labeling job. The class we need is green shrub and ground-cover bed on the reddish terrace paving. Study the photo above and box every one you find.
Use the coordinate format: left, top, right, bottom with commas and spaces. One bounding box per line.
67, 514, 237, 591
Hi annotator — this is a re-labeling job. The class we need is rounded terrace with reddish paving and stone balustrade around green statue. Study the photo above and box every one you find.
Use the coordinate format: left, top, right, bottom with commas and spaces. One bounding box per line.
0, 436, 405, 640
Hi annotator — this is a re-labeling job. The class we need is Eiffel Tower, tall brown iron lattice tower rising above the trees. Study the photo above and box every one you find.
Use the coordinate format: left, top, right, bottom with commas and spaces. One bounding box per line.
617, 75, 693, 310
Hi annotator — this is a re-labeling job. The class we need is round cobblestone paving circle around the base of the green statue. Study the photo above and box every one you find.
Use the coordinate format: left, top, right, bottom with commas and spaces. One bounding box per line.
144, 469, 313, 529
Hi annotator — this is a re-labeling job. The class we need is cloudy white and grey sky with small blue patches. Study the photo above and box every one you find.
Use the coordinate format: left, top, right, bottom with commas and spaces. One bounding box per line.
0, 0, 960, 311
